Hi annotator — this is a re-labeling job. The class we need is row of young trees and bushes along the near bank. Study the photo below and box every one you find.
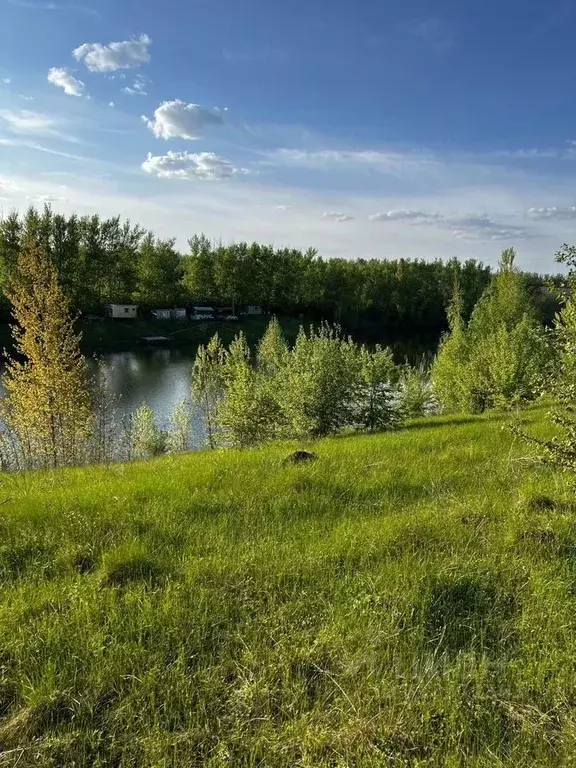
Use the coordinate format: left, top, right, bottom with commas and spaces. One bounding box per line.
0, 225, 576, 469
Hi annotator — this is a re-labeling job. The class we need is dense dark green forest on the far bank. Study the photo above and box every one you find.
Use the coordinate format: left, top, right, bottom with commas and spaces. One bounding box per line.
0, 207, 561, 339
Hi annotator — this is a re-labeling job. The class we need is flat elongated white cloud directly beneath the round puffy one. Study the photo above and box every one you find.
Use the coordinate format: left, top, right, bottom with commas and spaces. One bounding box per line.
142, 152, 248, 181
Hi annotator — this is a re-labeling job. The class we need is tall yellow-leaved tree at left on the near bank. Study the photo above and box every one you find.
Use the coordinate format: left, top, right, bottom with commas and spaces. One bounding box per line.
1, 233, 93, 468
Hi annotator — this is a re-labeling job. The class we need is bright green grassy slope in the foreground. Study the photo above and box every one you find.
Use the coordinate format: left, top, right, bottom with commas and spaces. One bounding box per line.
0, 409, 576, 768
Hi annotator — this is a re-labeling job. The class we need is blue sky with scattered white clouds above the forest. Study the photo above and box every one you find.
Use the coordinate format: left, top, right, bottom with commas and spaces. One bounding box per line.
0, 0, 576, 272
